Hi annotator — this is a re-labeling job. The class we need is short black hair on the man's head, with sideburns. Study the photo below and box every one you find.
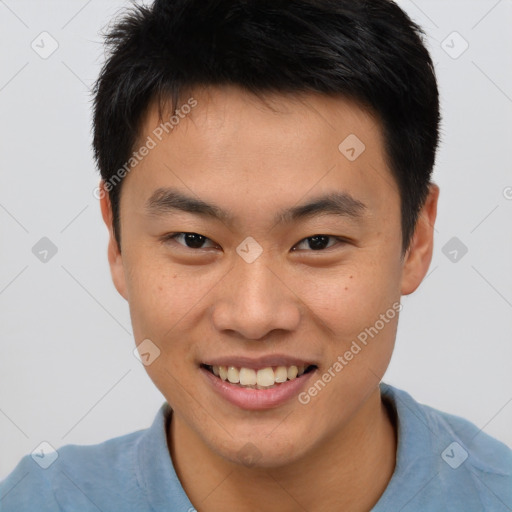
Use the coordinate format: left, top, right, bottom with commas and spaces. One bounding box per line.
93, 0, 440, 253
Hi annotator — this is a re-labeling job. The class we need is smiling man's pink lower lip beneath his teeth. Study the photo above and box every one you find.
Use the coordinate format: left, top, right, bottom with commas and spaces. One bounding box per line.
199, 367, 316, 411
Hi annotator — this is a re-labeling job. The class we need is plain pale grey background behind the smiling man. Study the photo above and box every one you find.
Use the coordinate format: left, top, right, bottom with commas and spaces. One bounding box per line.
0, 0, 512, 478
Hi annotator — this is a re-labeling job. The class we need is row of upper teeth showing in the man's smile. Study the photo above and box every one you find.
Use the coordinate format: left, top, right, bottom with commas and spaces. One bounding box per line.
212, 365, 306, 388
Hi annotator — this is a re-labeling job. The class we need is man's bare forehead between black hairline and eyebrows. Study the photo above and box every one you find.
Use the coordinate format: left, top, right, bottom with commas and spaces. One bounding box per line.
123, 87, 398, 226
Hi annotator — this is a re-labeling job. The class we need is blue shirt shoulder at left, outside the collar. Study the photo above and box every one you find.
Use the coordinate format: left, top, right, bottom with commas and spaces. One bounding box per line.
0, 430, 145, 512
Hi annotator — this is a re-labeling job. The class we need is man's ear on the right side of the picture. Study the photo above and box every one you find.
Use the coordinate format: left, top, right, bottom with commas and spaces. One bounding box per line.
401, 183, 439, 295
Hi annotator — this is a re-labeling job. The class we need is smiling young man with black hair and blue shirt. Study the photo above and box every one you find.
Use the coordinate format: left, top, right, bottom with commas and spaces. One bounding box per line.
0, 0, 512, 512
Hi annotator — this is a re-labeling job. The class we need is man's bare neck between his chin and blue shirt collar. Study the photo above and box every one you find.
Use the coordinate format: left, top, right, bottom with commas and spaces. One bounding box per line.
168, 388, 396, 512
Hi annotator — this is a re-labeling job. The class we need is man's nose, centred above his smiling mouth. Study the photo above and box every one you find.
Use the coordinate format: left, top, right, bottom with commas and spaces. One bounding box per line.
212, 257, 301, 340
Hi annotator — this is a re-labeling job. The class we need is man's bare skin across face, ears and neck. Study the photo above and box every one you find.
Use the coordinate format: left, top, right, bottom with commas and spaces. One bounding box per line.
101, 87, 439, 512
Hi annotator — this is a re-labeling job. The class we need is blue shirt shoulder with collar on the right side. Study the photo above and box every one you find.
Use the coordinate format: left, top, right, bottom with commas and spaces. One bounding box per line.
382, 385, 512, 512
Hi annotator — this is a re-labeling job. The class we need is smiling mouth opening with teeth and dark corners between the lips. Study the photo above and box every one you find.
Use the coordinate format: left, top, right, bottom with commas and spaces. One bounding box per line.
201, 364, 318, 390
